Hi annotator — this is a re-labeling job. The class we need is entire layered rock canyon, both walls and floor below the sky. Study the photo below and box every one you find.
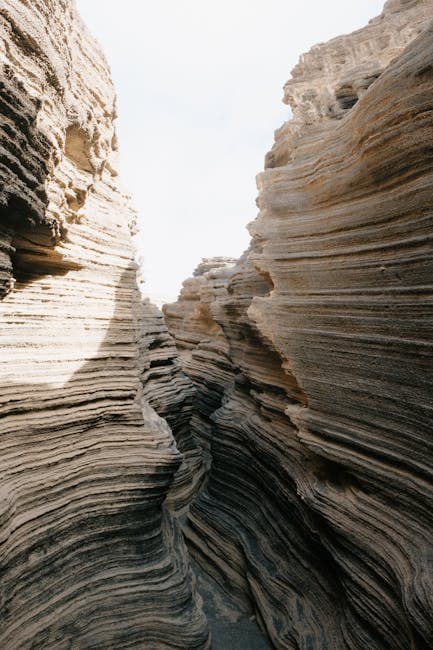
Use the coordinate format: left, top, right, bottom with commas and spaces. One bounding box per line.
0, 0, 433, 650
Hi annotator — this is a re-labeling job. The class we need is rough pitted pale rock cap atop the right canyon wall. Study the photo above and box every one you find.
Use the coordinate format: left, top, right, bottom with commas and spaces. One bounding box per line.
266, 0, 432, 167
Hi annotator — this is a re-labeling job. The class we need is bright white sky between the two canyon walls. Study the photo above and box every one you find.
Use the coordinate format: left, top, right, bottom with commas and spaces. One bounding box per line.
77, 0, 384, 297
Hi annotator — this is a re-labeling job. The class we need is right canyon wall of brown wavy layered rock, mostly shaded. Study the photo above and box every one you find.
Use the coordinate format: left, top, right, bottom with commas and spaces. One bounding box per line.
165, 0, 433, 650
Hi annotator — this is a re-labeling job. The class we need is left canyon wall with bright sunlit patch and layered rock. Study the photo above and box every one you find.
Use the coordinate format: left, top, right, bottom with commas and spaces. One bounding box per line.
0, 0, 209, 650
